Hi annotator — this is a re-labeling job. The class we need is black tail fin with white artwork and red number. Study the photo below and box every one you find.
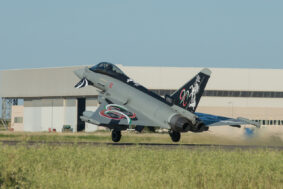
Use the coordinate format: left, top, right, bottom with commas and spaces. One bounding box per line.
171, 68, 211, 112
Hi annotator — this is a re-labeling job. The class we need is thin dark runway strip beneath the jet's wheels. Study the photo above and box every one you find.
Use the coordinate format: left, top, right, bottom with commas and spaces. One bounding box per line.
0, 140, 283, 151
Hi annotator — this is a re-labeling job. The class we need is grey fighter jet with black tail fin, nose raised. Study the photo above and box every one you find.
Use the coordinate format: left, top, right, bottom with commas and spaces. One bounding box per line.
74, 62, 260, 142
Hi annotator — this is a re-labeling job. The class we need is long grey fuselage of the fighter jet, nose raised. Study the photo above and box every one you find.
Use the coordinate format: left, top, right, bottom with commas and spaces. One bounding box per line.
76, 65, 199, 132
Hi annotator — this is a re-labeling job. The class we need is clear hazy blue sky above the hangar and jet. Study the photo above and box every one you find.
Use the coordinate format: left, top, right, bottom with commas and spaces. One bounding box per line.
0, 0, 283, 70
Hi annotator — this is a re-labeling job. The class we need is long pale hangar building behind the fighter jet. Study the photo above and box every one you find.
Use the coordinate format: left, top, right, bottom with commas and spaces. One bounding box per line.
0, 65, 283, 132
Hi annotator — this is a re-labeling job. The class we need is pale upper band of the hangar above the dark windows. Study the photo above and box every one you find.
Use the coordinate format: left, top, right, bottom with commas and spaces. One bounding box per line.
0, 65, 283, 98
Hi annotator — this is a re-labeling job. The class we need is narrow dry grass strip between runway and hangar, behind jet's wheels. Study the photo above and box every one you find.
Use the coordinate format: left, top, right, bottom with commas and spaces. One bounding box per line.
0, 131, 283, 146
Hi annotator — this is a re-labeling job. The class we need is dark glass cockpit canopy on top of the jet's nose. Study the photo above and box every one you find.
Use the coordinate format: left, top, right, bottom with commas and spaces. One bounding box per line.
90, 62, 127, 79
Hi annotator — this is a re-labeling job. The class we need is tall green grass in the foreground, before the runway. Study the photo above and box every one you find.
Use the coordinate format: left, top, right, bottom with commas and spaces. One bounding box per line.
0, 144, 283, 189
